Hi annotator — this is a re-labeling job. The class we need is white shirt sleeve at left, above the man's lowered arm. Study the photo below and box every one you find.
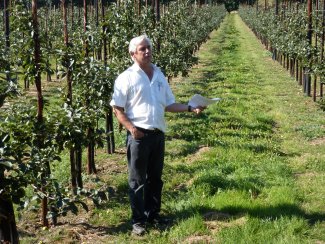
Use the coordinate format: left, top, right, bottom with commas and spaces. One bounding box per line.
110, 73, 128, 108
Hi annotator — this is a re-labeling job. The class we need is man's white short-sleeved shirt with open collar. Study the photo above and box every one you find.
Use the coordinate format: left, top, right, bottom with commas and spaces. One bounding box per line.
110, 63, 175, 132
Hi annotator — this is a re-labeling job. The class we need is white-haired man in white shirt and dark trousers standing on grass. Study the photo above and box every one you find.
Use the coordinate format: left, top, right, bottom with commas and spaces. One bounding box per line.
110, 35, 204, 235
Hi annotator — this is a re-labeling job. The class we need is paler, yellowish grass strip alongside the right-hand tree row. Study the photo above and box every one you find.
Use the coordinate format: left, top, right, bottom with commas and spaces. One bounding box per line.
229, 12, 325, 213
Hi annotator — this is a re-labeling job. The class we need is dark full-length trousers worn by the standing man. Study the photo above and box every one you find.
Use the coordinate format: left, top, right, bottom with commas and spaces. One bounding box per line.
127, 130, 165, 224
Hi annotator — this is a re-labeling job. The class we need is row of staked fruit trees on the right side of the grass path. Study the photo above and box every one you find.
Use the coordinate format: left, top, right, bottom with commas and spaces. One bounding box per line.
240, 0, 325, 101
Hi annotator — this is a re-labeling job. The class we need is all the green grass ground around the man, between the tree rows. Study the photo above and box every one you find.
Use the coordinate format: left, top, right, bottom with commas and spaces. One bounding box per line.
19, 14, 325, 243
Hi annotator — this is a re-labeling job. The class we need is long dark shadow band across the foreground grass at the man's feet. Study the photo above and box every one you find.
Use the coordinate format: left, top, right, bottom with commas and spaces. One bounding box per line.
19, 204, 325, 237
